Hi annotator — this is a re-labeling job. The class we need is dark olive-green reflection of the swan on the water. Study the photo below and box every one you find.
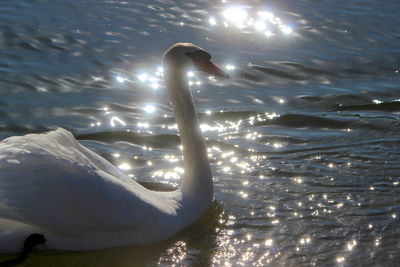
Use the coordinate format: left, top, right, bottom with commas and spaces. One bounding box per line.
12, 202, 225, 267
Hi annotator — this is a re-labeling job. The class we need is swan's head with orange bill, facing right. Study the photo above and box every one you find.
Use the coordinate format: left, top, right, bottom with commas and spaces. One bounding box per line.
163, 43, 229, 78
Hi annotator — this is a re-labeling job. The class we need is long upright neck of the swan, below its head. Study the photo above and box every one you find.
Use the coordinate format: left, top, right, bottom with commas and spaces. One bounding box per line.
165, 69, 213, 209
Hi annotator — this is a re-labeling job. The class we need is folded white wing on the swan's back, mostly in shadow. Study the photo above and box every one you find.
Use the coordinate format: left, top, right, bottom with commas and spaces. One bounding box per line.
0, 130, 162, 233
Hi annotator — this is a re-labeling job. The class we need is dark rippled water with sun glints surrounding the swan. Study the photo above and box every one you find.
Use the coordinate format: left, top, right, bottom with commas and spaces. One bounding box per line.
0, 0, 400, 266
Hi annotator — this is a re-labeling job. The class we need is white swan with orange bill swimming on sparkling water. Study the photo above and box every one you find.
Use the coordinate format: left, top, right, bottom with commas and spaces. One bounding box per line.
0, 43, 226, 253
